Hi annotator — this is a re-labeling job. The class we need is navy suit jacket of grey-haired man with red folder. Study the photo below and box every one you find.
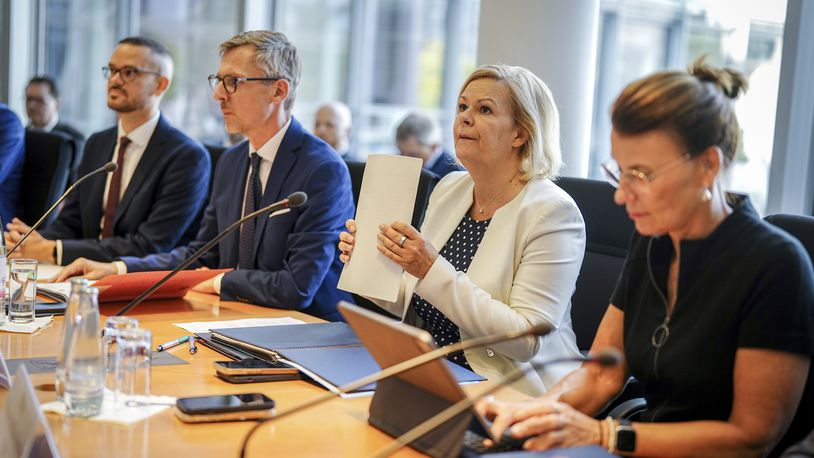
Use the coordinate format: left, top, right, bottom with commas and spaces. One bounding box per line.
122, 118, 354, 321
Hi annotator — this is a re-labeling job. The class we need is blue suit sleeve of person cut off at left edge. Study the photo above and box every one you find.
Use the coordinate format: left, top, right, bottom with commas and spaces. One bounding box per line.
0, 103, 25, 225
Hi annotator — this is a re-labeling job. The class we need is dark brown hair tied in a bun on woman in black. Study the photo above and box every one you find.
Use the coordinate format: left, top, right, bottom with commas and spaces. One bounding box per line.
611, 57, 747, 165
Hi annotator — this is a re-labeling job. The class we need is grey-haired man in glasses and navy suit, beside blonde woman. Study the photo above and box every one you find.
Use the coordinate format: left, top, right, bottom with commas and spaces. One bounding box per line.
57, 31, 354, 321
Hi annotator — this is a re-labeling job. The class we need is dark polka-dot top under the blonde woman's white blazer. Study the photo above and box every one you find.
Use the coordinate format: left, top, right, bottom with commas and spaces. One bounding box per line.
410, 214, 492, 369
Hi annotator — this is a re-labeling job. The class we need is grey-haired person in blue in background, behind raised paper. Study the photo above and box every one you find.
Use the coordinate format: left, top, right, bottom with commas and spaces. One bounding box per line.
396, 113, 462, 178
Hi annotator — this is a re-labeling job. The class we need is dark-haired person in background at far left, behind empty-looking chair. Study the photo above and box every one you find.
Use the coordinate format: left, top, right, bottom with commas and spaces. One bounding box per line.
25, 76, 85, 182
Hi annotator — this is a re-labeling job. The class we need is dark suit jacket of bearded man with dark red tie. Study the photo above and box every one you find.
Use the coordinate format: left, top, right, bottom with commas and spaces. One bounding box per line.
42, 115, 210, 264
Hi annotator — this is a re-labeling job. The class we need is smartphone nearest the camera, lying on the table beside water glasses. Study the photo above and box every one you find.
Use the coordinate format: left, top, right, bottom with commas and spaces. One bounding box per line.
175, 393, 274, 423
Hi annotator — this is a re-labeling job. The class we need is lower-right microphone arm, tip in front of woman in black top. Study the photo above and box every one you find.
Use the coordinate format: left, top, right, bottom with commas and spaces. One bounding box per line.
373, 348, 623, 458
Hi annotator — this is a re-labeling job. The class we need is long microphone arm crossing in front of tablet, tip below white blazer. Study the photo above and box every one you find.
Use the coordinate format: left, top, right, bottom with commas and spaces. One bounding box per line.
240, 323, 556, 458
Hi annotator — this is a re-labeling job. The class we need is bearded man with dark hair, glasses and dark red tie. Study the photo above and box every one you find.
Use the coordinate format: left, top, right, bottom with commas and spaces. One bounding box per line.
8, 37, 210, 265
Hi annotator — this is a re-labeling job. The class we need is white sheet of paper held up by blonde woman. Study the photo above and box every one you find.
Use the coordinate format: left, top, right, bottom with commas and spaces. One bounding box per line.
337, 155, 428, 302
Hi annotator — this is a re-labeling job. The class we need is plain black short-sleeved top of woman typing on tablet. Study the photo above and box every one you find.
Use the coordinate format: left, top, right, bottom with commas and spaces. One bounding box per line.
611, 195, 814, 450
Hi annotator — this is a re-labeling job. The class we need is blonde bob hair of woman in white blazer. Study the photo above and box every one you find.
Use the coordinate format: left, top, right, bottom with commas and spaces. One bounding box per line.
460, 64, 562, 181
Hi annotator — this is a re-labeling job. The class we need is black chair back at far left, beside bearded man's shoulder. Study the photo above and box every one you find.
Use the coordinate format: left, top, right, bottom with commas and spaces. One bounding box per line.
20, 130, 75, 229
